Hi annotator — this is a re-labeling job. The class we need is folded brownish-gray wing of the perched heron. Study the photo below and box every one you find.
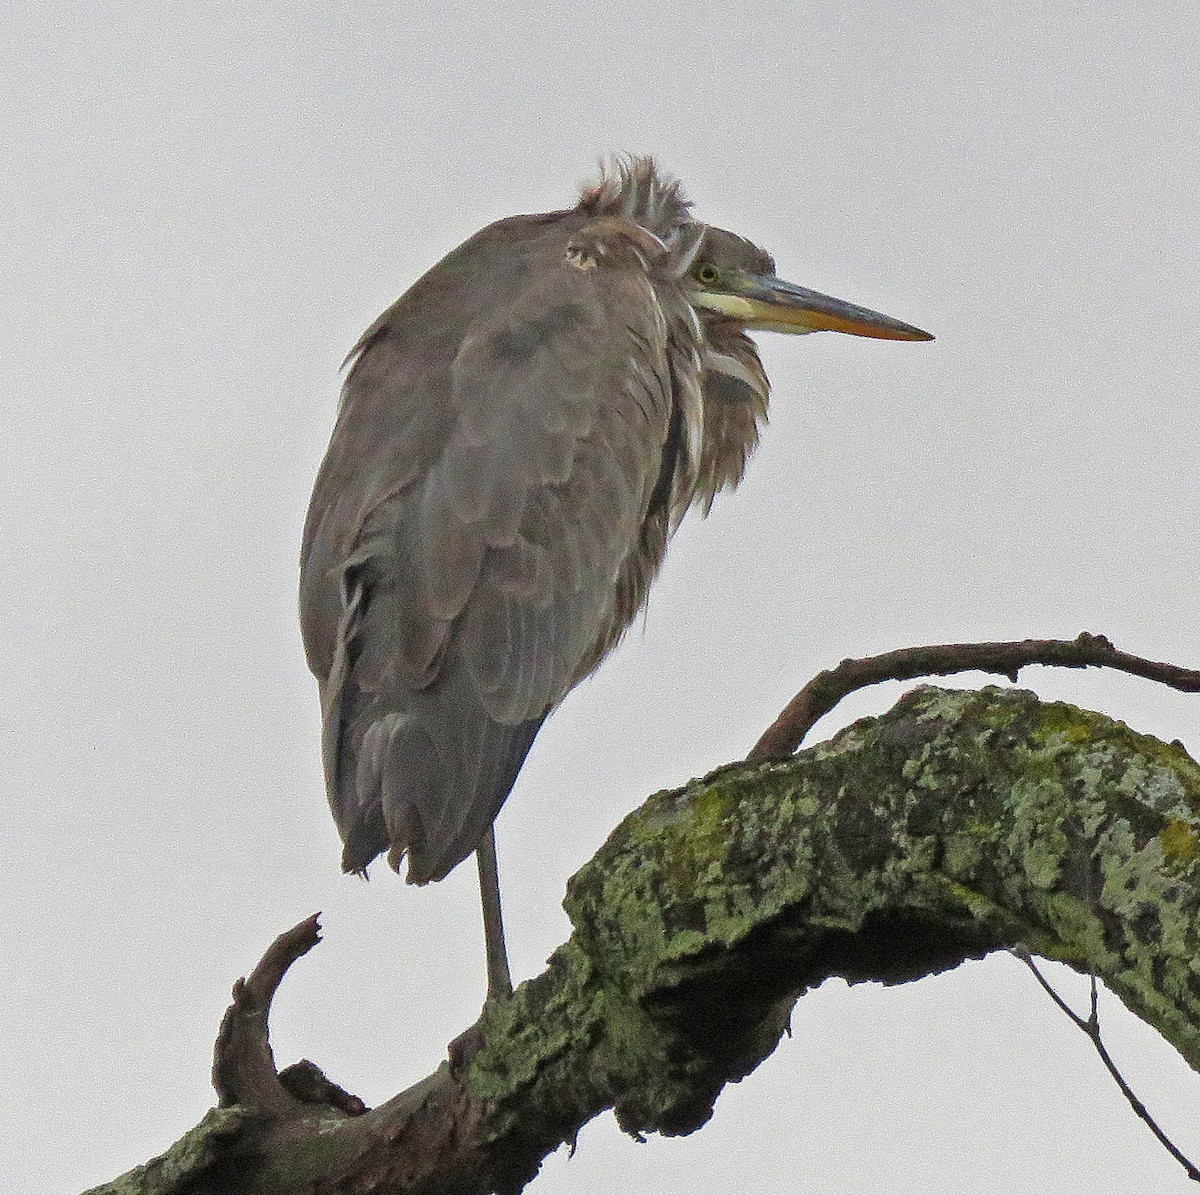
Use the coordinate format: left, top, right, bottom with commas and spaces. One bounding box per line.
301, 247, 672, 882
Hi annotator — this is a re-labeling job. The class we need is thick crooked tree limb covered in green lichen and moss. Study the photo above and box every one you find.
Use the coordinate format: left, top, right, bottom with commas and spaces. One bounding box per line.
82, 687, 1200, 1195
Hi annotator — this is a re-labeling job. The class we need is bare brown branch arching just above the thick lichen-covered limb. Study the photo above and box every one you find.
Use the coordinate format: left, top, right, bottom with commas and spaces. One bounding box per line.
746, 631, 1200, 759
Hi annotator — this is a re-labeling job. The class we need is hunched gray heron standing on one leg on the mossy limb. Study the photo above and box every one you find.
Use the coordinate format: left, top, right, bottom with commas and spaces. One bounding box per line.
300, 158, 931, 998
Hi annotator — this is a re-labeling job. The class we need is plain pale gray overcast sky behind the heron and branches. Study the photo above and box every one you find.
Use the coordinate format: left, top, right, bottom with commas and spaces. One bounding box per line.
0, 0, 1200, 1195
